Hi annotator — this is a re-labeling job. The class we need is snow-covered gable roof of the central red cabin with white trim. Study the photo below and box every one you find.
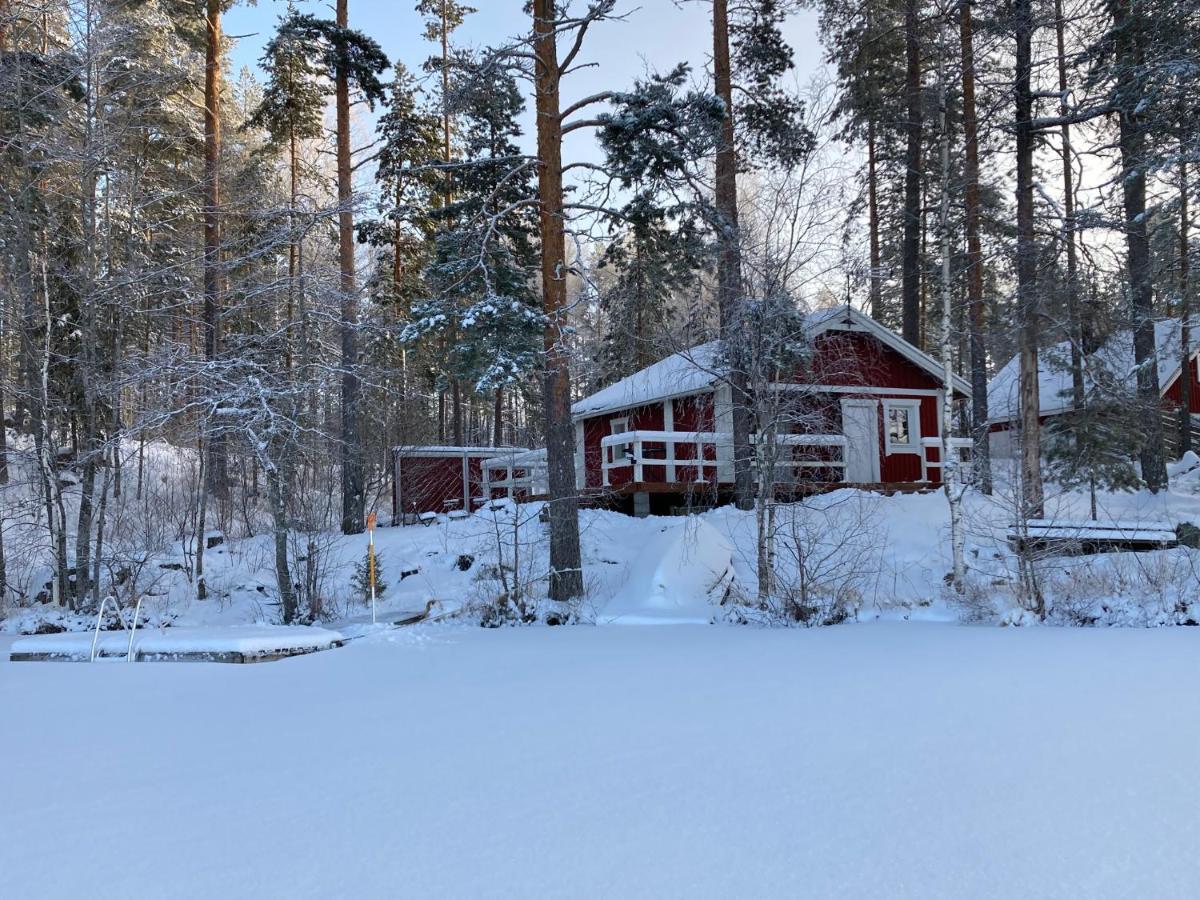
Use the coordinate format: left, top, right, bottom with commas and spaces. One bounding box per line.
571, 306, 971, 419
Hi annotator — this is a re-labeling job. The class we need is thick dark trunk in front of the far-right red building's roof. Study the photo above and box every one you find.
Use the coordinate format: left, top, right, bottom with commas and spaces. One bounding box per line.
1112, 0, 1166, 492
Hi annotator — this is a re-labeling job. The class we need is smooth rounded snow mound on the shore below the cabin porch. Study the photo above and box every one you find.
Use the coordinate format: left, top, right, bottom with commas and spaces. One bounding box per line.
599, 518, 733, 625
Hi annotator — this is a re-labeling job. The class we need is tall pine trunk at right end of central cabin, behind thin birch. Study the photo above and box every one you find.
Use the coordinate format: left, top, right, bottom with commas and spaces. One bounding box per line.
959, 0, 991, 494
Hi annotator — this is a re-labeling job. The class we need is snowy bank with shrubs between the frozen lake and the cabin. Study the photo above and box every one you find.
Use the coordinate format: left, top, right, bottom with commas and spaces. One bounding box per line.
11, 436, 1200, 634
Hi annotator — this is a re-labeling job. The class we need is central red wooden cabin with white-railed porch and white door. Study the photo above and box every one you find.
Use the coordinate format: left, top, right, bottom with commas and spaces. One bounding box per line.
572, 307, 971, 512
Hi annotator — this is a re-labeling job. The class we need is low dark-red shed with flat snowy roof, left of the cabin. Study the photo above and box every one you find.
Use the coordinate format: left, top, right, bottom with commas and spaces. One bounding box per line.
391, 446, 527, 523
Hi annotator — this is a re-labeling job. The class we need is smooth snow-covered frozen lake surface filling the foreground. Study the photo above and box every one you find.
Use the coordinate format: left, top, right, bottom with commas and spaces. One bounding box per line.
0, 624, 1200, 898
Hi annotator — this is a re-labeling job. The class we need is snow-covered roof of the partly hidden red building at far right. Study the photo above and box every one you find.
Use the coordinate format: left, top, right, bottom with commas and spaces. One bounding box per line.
988, 319, 1200, 424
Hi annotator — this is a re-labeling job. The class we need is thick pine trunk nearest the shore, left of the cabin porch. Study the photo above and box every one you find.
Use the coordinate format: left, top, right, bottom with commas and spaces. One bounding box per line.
533, 0, 583, 600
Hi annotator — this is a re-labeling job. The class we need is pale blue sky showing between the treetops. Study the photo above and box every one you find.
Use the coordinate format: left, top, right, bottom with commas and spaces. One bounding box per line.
224, 0, 821, 158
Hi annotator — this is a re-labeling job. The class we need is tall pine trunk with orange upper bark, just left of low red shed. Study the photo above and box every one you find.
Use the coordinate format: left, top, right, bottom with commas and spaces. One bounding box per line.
334, 0, 366, 534
